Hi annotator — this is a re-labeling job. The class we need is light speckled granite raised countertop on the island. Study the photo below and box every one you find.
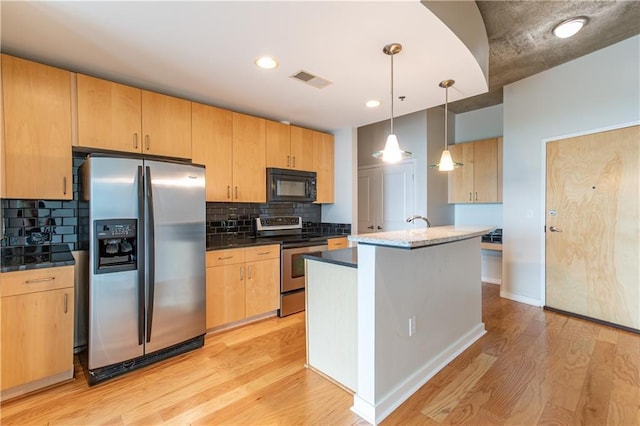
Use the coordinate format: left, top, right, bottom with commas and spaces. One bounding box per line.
349, 225, 494, 249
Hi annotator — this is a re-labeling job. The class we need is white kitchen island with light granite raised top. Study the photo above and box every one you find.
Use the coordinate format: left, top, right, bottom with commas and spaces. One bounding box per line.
307, 226, 490, 424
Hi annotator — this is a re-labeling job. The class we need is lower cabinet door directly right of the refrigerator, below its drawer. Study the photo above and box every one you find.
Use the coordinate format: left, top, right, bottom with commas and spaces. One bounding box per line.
206, 263, 245, 329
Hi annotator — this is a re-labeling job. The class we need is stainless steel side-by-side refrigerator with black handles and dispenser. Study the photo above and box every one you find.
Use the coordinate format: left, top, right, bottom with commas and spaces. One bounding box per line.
80, 155, 206, 384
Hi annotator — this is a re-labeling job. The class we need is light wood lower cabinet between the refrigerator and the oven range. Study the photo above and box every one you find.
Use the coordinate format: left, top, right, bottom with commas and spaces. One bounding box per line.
207, 244, 280, 329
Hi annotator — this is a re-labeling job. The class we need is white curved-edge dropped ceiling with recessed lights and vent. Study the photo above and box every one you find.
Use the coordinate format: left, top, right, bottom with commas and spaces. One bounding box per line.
0, 1, 487, 131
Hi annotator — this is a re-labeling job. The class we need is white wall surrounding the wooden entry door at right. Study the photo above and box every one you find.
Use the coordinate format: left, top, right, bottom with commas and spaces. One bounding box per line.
501, 36, 640, 304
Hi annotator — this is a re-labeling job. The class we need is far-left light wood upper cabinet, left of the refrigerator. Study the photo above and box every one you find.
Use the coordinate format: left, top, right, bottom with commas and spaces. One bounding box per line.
2, 55, 73, 200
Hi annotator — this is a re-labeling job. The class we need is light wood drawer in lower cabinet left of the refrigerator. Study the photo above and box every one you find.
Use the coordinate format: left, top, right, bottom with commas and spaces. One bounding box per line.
0, 266, 74, 297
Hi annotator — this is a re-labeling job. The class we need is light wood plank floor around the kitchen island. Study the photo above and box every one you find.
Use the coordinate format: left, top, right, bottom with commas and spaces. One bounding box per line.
0, 284, 640, 426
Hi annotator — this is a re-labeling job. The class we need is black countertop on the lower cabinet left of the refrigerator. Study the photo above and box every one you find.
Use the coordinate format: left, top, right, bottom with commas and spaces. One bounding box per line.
0, 244, 76, 272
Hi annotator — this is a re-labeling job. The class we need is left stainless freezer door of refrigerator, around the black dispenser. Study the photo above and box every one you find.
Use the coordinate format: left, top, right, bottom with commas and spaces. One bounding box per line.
83, 157, 144, 369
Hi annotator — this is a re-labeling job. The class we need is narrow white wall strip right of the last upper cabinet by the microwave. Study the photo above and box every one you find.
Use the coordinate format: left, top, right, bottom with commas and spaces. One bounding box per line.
321, 127, 358, 224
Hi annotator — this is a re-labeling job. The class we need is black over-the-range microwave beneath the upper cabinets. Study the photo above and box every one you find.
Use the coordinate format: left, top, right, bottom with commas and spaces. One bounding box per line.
267, 167, 316, 203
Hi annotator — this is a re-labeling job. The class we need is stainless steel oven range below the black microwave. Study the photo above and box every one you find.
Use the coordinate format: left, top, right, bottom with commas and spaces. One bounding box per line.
256, 216, 327, 317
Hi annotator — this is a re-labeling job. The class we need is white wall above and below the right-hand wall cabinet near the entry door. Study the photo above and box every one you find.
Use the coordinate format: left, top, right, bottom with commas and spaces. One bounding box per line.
455, 105, 503, 228
